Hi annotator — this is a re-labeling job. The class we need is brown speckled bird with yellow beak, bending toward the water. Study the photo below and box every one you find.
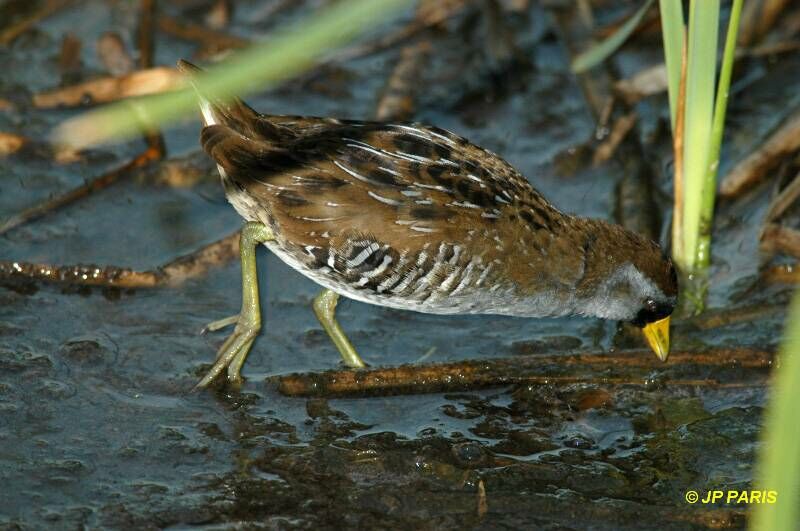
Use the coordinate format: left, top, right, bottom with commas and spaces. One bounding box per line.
178, 61, 677, 387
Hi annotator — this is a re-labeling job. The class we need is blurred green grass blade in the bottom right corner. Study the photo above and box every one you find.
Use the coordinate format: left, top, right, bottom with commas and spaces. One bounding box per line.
750, 291, 800, 531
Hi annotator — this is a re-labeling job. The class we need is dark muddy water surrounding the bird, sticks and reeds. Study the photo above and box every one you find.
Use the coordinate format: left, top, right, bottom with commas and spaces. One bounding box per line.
0, 1, 800, 529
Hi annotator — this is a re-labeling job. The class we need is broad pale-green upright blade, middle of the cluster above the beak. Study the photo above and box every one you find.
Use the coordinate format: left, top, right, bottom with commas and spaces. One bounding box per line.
675, 0, 720, 272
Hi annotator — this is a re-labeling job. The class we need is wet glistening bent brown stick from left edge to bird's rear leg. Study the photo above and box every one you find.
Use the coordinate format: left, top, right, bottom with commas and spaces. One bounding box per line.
0, 231, 239, 288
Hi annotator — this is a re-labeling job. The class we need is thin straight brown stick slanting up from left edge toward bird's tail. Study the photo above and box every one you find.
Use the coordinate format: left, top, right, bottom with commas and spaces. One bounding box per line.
0, 146, 161, 235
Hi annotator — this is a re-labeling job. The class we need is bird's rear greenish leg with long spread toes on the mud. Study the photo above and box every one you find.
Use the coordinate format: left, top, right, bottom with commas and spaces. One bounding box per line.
195, 222, 275, 389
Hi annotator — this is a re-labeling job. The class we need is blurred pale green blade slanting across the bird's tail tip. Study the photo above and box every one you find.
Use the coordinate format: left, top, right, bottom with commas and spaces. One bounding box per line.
54, 0, 411, 147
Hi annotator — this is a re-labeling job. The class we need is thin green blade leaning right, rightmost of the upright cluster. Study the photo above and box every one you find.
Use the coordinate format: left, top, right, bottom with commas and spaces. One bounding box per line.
695, 0, 743, 269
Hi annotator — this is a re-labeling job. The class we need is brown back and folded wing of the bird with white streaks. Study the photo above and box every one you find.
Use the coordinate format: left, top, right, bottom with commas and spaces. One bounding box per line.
202, 117, 576, 300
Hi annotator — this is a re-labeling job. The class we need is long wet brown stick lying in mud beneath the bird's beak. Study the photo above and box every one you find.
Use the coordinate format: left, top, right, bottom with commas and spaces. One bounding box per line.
267, 349, 774, 397
